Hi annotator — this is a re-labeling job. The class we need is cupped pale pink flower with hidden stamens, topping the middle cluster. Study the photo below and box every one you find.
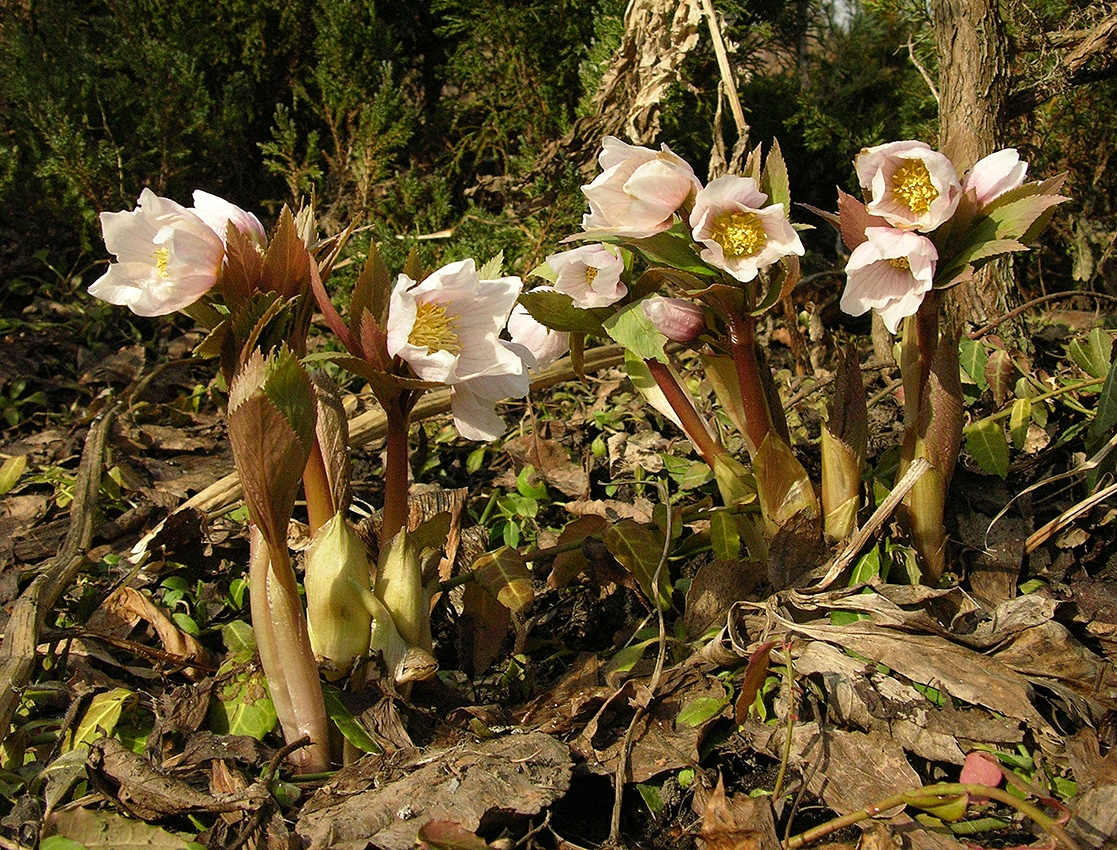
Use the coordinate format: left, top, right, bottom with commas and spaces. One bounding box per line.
582, 136, 701, 239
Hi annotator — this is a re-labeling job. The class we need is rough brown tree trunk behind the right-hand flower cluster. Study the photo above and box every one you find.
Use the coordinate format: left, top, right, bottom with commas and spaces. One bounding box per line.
930, 0, 1020, 342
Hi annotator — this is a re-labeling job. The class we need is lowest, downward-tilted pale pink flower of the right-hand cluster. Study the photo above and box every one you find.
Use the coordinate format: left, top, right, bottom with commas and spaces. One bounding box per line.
841, 227, 938, 334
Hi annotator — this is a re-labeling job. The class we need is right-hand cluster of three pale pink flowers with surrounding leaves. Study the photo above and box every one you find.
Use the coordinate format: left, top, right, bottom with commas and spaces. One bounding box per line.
839, 141, 1061, 333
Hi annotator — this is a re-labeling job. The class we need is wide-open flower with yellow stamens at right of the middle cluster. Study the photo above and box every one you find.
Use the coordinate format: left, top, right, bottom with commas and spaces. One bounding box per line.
690, 174, 803, 283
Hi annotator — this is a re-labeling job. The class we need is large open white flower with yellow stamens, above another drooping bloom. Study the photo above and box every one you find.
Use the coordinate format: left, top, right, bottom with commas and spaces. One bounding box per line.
388, 259, 523, 385
